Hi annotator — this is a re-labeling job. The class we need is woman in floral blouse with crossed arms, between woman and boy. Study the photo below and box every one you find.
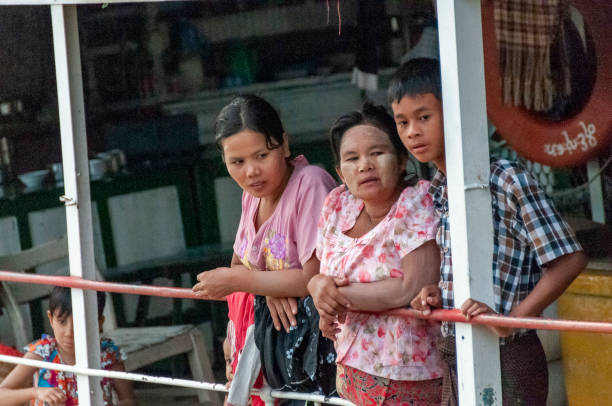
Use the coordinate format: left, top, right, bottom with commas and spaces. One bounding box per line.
308, 104, 442, 406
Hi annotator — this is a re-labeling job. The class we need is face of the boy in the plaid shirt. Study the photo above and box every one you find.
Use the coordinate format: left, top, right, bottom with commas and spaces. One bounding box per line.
391, 93, 446, 173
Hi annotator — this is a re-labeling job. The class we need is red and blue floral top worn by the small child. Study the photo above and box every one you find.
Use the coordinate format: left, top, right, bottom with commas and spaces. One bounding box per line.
24, 334, 126, 406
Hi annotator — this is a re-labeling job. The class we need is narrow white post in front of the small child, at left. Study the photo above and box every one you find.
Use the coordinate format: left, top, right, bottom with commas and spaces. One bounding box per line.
51, 5, 102, 406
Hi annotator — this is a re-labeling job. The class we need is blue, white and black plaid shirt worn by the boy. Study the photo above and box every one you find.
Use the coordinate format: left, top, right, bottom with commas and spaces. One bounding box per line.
429, 158, 582, 335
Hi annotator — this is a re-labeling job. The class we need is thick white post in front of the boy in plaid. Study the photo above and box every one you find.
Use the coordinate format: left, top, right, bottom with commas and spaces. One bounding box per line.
437, 0, 502, 406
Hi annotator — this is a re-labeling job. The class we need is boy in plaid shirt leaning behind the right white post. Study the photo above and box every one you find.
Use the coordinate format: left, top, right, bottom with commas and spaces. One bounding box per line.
388, 59, 587, 405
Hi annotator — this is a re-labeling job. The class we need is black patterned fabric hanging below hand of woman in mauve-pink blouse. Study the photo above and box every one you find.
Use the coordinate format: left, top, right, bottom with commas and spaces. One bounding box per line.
255, 296, 336, 395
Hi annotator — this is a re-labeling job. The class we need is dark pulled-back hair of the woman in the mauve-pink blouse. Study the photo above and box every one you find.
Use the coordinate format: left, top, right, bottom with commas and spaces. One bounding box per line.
215, 94, 285, 154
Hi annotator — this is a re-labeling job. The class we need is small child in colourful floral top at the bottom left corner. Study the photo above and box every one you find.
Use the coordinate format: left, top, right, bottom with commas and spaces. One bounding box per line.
0, 287, 136, 406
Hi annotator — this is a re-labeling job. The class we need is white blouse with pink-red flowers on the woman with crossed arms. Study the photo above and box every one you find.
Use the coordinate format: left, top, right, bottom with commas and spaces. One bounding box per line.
317, 181, 442, 381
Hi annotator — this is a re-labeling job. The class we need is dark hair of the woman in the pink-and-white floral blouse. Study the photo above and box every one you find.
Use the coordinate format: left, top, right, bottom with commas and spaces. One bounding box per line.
329, 102, 408, 166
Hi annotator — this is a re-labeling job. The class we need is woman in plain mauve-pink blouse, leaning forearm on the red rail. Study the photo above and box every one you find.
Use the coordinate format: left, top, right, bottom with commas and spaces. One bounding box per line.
193, 95, 336, 404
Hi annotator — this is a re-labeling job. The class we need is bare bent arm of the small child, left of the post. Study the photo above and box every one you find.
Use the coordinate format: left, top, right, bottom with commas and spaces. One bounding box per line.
0, 353, 66, 406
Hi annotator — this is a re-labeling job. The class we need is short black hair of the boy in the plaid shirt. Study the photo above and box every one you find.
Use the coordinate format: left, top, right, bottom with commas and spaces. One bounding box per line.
387, 58, 442, 104
